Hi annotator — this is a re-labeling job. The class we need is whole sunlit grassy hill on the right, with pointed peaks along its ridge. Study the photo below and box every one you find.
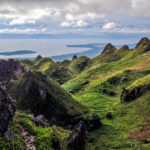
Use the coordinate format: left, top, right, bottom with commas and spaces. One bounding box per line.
62, 38, 150, 150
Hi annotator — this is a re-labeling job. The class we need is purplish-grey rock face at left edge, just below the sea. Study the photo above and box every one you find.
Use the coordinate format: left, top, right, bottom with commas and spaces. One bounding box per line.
0, 59, 25, 81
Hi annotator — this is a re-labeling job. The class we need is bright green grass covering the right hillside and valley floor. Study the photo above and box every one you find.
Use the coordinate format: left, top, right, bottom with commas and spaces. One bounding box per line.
62, 39, 150, 150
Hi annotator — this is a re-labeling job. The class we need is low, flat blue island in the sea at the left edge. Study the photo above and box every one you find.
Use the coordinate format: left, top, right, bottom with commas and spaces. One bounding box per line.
0, 50, 37, 56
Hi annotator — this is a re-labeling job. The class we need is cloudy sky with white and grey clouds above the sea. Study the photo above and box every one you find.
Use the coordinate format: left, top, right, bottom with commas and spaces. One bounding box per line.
0, 0, 150, 37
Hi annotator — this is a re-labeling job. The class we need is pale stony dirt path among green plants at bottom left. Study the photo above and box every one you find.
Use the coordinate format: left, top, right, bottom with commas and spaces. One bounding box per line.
21, 127, 36, 150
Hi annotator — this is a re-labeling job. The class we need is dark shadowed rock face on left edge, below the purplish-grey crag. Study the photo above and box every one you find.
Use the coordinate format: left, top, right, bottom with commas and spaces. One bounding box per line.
0, 87, 16, 136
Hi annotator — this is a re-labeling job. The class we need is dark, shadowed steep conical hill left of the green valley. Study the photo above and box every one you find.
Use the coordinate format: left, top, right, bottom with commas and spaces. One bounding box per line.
8, 72, 100, 129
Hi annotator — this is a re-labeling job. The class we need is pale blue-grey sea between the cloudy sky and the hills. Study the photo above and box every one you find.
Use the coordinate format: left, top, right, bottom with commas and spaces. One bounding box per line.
0, 38, 135, 59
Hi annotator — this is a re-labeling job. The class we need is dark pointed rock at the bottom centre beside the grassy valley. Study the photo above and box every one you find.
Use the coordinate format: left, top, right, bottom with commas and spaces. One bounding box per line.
68, 121, 86, 150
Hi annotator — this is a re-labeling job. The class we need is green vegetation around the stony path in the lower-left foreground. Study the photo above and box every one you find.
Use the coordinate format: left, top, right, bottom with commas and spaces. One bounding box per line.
0, 111, 70, 150
